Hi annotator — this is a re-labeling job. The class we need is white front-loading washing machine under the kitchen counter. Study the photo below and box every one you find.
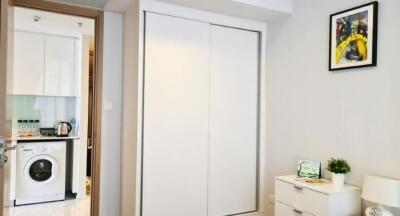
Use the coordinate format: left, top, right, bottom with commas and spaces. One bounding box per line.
15, 141, 67, 206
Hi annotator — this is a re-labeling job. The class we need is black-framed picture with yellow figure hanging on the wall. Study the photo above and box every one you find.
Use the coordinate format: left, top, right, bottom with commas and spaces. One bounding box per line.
329, 2, 378, 71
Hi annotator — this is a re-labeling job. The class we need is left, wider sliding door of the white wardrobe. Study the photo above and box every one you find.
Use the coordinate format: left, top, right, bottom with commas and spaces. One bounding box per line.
142, 13, 210, 216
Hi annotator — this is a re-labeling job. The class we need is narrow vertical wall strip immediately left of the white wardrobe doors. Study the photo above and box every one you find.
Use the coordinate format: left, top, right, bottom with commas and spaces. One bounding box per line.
120, 1, 139, 216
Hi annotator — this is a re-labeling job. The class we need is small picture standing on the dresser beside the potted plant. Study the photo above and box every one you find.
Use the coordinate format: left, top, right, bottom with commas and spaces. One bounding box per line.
297, 160, 322, 179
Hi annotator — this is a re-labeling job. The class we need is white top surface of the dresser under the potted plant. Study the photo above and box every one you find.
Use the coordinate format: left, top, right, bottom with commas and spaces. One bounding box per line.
276, 175, 361, 195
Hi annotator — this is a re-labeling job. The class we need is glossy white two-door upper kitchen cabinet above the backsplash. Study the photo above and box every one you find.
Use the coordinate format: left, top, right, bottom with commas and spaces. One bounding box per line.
13, 31, 77, 97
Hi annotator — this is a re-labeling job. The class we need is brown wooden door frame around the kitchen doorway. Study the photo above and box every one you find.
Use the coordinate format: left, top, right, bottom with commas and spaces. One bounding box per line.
4, 0, 104, 216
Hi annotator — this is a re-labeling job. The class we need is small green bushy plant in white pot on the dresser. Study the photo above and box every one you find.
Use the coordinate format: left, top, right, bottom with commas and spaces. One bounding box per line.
327, 158, 351, 187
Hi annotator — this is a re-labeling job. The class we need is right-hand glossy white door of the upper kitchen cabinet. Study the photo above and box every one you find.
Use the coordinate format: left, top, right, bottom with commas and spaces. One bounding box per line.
44, 35, 76, 97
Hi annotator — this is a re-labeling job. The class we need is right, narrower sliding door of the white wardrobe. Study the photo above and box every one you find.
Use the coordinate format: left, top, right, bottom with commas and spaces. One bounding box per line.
208, 26, 259, 216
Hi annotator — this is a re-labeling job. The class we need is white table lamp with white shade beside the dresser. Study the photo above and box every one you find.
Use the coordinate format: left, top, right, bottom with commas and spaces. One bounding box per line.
362, 175, 400, 216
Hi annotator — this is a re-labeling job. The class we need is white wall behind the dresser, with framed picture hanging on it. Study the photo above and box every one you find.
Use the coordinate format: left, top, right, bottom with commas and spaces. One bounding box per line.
267, 0, 400, 215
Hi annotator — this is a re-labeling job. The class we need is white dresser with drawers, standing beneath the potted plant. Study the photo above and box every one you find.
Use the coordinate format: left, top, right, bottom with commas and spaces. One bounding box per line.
275, 175, 361, 216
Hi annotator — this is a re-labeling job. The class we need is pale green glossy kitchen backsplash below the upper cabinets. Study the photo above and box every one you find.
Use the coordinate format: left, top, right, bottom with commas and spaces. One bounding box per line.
12, 96, 76, 129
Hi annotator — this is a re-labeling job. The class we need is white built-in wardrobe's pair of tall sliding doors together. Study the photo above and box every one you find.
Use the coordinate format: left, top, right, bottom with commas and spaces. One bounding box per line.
141, 12, 260, 216
